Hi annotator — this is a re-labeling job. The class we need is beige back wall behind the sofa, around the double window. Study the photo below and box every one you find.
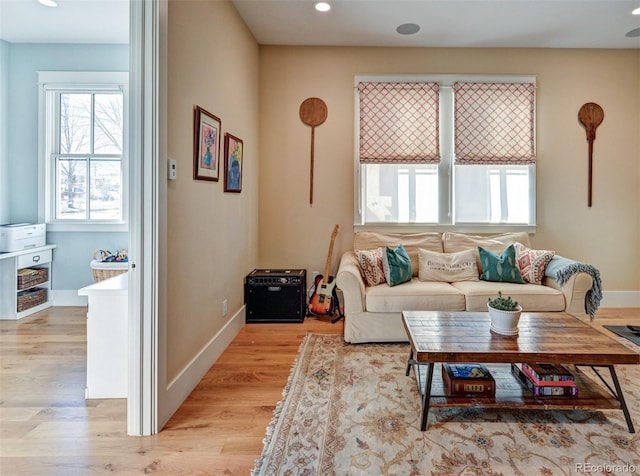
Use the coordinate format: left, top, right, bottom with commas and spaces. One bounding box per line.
259, 46, 640, 291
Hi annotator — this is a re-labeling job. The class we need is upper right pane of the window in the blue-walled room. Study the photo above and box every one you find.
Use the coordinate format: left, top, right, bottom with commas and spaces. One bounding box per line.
94, 94, 122, 154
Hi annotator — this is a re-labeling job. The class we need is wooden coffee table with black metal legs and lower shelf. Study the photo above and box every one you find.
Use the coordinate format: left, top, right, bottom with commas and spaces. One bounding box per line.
402, 311, 640, 433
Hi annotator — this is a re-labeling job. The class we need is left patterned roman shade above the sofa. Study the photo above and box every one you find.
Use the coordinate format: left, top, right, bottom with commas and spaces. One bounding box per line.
358, 82, 440, 164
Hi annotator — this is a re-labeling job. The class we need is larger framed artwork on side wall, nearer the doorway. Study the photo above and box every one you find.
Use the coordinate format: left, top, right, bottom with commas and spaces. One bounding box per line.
193, 106, 222, 182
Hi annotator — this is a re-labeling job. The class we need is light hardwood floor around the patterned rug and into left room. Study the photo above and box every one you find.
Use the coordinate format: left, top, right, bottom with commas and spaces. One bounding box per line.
0, 307, 640, 476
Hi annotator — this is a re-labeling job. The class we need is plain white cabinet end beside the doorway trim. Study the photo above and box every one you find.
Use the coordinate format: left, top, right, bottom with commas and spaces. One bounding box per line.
78, 273, 129, 398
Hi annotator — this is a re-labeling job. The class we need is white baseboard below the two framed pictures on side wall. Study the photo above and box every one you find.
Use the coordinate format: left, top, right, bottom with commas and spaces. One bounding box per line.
158, 306, 246, 428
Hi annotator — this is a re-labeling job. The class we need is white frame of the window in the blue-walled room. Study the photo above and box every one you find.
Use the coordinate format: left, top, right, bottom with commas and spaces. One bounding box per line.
38, 71, 129, 232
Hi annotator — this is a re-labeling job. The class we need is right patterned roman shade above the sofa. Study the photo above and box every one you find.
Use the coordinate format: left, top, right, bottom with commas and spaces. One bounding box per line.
453, 83, 536, 165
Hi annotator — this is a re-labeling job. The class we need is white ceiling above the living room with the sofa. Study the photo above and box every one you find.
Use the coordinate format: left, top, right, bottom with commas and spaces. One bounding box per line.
233, 0, 640, 48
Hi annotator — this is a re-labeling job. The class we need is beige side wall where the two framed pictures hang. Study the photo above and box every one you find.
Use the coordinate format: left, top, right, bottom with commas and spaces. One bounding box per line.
166, 0, 259, 382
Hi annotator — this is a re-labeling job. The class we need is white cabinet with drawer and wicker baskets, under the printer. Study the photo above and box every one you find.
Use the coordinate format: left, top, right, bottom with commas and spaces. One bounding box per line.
0, 245, 56, 320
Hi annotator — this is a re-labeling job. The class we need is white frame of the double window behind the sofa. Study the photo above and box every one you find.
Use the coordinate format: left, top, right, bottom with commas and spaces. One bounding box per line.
353, 74, 537, 233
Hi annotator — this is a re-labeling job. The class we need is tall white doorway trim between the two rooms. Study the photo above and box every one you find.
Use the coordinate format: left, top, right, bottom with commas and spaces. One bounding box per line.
127, 0, 168, 436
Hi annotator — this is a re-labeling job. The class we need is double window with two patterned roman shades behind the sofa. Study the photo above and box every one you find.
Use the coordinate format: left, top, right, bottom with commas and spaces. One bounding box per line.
354, 74, 536, 233
